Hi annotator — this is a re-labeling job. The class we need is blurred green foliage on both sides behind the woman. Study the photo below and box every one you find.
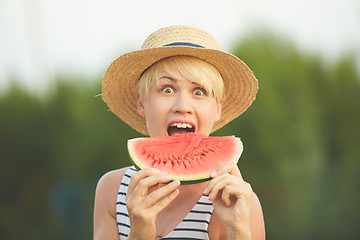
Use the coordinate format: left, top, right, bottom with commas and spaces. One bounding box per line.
0, 34, 360, 240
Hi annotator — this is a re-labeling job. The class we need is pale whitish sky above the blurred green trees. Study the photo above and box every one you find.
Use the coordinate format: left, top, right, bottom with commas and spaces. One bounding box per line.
0, 0, 360, 92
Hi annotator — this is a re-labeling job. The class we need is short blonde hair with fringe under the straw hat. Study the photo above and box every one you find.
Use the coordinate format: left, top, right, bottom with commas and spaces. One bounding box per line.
137, 56, 224, 103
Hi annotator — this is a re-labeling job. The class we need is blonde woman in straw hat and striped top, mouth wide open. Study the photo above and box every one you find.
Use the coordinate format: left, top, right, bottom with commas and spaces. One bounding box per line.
94, 26, 265, 239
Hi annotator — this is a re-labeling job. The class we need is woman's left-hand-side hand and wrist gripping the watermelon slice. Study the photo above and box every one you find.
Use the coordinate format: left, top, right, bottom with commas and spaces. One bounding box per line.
126, 168, 180, 239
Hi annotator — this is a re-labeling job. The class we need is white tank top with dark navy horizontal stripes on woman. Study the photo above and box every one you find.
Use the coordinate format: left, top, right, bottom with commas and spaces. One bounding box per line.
116, 166, 213, 240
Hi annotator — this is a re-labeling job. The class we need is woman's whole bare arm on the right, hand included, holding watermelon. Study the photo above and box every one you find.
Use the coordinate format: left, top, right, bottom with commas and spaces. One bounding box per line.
205, 164, 265, 240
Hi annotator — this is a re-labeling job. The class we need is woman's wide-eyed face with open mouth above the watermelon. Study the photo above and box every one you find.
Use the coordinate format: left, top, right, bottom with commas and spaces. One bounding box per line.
137, 66, 221, 137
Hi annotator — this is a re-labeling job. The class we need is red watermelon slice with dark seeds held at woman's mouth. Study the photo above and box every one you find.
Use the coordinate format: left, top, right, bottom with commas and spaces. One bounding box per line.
128, 133, 243, 184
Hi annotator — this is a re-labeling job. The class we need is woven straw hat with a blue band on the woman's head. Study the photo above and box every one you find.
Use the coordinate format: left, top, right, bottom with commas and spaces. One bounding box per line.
102, 26, 258, 135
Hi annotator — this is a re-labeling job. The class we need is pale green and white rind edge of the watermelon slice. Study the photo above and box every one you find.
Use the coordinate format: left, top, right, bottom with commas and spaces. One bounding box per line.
128, 137, 243, 185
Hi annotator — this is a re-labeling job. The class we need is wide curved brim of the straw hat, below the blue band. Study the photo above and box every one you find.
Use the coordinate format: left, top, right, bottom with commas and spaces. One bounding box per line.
102, 46, 258, 135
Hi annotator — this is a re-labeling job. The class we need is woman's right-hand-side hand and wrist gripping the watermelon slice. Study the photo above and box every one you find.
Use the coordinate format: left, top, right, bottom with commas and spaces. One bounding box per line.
204, 163, 252, 239
